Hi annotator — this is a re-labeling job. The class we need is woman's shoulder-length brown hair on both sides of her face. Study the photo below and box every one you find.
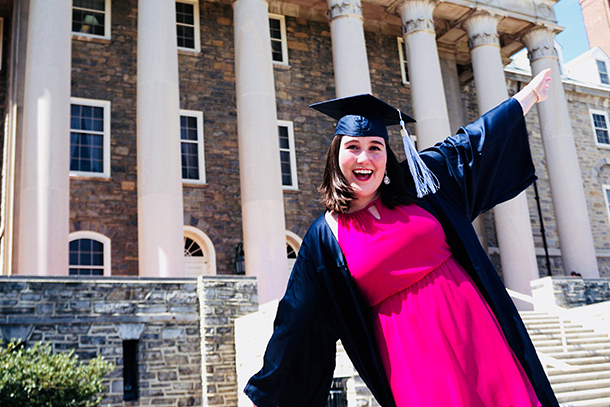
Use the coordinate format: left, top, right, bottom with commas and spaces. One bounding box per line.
318, 134, 414, 213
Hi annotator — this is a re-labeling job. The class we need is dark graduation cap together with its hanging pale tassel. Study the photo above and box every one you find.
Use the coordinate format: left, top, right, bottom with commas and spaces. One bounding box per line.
309, 94, 439, 198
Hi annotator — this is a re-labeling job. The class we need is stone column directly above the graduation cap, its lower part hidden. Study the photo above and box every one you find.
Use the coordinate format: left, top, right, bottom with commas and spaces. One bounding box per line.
328, 0, 372, 98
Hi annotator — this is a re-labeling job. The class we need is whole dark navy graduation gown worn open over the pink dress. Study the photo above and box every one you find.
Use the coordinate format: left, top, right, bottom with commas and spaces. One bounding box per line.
245, 98, 558, 407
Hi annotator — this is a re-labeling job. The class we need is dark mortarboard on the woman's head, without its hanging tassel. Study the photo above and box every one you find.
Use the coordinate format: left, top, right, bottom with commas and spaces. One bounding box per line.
309, 94, 415, 141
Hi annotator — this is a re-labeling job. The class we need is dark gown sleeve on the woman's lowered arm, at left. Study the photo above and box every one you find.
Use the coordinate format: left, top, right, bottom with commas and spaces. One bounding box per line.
244, 239, 338, 407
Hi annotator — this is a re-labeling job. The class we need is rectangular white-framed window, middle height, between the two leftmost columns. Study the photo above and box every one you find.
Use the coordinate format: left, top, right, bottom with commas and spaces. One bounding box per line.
70, 98, 110, 177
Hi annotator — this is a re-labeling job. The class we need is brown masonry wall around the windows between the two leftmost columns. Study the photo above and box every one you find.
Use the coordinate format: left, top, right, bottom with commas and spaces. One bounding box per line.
70, 0, 138, 275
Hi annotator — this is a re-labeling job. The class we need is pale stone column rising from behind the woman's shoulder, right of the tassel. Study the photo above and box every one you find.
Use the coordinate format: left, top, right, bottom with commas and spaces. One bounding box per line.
398, 0, 452, 149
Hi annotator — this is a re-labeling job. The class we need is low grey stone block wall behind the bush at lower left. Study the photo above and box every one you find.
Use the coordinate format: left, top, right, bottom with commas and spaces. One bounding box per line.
0, 276, 258, 407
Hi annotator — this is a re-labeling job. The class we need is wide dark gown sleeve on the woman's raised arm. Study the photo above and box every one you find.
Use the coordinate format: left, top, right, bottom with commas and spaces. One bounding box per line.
420, 98, 536, 221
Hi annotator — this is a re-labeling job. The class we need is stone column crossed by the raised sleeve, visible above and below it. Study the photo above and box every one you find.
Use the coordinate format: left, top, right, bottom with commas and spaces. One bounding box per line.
464, 12, 538, 309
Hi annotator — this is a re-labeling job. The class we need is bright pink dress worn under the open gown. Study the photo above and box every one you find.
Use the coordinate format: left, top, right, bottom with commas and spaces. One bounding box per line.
338, 200, 541, 407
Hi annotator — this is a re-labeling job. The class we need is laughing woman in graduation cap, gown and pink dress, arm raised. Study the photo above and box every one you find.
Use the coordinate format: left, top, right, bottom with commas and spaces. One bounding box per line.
245, 70, 558, 407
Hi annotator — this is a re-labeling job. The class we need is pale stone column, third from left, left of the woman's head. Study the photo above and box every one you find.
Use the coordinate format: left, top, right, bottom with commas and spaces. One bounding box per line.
233, 0, 288, 304
